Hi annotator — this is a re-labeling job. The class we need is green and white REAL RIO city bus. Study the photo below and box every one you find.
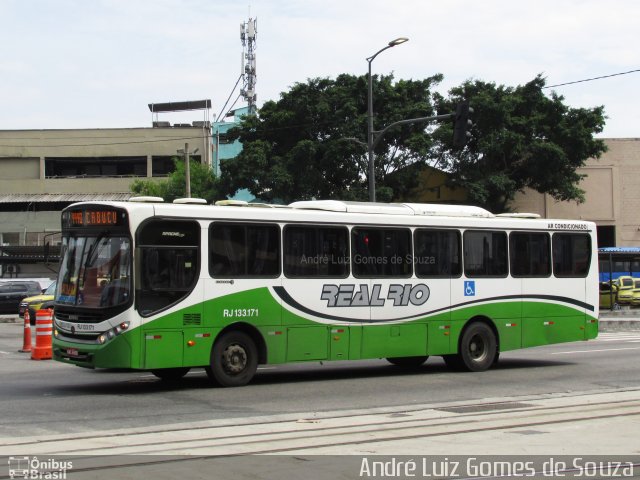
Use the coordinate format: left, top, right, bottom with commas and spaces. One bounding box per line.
53, 197, 598, 386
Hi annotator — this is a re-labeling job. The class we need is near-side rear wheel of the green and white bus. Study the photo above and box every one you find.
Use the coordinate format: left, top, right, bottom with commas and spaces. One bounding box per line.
458, 322, 498, 372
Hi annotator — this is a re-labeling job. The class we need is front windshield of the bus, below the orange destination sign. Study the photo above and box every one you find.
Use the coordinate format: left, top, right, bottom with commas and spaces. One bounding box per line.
56, 233, 131, 308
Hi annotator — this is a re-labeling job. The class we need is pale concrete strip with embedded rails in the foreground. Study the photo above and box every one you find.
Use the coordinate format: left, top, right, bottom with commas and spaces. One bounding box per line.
0, 387, 640, 456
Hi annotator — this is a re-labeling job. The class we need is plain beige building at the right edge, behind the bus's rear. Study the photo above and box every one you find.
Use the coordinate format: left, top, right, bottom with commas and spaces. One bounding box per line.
513, 138, 640, 247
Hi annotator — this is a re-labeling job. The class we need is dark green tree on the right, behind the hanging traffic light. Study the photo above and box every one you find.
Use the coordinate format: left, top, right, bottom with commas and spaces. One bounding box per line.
432, 75, 606, 212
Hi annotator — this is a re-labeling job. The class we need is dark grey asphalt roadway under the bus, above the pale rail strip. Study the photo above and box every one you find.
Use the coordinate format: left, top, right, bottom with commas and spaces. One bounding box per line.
0, 324, 640, 436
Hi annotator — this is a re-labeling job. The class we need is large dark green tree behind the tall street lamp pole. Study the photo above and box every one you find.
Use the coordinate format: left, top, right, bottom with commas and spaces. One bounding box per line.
221, 74, 441, 202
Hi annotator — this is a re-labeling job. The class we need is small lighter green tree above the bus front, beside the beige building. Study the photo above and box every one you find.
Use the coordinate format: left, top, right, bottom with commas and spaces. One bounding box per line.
131, 157, 226, 203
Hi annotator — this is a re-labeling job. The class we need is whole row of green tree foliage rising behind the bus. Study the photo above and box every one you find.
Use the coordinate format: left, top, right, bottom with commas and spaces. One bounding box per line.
141, 74, 606, 212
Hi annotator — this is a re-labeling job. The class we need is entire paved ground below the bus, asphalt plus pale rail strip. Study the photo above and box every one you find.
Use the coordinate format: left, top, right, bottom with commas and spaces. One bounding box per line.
0, 324, 640, 478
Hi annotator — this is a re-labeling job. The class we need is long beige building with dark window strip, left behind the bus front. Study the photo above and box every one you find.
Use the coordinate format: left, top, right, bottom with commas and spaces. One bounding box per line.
0, 126, 211, 278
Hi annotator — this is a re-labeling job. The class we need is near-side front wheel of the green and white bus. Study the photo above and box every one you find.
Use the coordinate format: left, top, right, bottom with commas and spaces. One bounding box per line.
206, 331, 258, 387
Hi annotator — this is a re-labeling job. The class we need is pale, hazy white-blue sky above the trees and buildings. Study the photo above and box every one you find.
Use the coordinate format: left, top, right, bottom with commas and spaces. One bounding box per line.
0, 0, 640, 138
